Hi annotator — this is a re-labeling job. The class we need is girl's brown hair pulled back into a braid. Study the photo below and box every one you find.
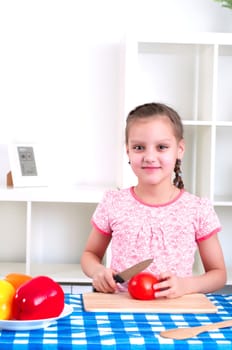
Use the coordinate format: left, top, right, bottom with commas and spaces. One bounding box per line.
125, 102, 184, 188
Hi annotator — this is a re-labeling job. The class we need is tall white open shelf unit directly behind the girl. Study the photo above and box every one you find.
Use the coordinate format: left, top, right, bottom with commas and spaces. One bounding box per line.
121, 33, 232, 284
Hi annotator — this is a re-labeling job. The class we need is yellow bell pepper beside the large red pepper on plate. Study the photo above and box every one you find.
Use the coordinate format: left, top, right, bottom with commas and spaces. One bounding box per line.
0, 280, 16, 320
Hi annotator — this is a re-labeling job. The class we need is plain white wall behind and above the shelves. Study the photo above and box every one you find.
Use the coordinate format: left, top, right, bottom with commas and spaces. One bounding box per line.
0, 0, 232, 185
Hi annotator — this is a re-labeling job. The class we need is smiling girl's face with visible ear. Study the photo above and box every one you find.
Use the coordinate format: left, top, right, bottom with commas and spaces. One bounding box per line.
127, 116, 184, 185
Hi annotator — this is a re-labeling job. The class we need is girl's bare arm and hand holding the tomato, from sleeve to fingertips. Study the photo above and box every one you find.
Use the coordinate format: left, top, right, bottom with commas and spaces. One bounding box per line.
154, 234, 226, 298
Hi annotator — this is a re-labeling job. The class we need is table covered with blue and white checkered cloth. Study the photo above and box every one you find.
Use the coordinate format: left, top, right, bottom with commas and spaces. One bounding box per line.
0, 294, 232, 350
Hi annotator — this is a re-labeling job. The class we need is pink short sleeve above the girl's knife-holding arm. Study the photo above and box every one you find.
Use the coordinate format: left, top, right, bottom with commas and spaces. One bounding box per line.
91, 191, 112, 235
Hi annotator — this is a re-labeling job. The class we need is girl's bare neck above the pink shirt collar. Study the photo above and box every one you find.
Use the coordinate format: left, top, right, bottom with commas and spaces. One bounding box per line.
134, 184, 180, 205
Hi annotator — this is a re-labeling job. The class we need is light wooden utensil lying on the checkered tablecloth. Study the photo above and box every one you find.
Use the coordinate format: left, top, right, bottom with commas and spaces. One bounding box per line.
160, 320, 232, 340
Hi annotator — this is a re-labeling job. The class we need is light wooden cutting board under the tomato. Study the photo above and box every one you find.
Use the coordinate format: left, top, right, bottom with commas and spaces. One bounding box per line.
83, 292, 217, 313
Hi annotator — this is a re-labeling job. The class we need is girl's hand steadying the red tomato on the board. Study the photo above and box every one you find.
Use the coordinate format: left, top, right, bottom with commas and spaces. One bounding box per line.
153, 272, 187, 298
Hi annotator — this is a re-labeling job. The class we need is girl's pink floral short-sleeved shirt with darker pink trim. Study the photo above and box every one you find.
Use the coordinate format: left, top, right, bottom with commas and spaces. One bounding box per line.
92, 188, 221, 277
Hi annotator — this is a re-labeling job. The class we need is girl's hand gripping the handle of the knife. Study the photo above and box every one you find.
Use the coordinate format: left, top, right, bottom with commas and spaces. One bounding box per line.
92, 265, 117, 293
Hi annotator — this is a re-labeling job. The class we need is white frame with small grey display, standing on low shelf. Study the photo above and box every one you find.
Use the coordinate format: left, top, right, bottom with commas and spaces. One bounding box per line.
8, 144, 47, 187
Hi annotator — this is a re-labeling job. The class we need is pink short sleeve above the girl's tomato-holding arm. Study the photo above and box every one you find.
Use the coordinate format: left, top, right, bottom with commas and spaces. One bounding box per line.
196, 198, 221, 241
